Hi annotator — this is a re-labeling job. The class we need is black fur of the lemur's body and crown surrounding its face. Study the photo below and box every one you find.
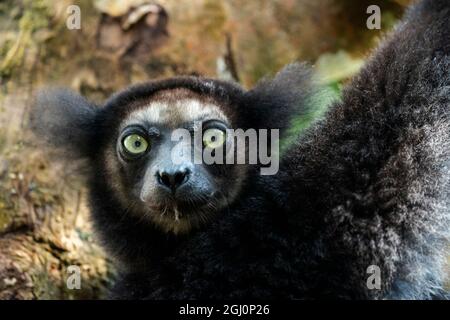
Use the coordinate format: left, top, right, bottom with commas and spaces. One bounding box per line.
32, 0, 450, 299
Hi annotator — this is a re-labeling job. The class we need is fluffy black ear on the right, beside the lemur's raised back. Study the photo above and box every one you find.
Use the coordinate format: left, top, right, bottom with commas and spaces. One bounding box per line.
244, 63, 314, 133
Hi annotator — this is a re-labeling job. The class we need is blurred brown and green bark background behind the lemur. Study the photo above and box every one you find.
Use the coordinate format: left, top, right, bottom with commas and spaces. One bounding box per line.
0, 0, 416, 298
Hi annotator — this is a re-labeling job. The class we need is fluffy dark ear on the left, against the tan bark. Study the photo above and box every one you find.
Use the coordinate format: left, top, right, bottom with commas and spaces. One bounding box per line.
30, 88, 97, 158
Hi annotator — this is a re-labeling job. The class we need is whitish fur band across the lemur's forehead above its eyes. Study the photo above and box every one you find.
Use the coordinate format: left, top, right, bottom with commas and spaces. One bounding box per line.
123, 99, 228, 128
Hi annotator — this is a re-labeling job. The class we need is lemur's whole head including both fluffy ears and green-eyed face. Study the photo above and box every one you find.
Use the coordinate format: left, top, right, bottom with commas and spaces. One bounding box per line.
31, 64, 309, 233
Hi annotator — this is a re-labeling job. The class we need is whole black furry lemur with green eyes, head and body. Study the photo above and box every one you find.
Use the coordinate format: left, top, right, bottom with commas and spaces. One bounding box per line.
31, 0, 450, 299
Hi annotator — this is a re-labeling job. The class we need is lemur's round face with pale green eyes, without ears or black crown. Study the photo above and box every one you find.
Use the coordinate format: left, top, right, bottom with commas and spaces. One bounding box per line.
104, 89, 246, 233
